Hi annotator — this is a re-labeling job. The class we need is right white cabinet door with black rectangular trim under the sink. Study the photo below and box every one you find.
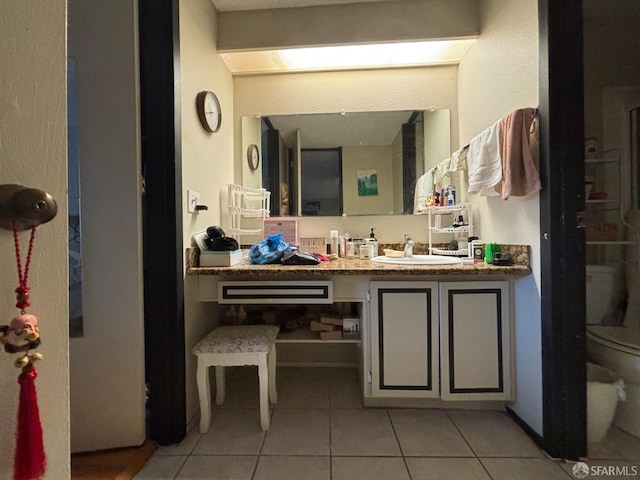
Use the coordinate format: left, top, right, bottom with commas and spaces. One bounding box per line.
440, 282, 512, 400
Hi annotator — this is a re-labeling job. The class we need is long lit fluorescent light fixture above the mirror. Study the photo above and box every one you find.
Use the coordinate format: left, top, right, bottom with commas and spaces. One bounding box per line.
220, 38, 475, 74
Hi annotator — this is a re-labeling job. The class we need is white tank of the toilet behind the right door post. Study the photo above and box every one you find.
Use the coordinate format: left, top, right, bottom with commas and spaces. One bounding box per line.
586, 265, 620, 325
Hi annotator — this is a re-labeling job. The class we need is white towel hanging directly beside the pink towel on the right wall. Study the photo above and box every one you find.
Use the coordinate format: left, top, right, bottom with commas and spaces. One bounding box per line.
467, 122, 502, 194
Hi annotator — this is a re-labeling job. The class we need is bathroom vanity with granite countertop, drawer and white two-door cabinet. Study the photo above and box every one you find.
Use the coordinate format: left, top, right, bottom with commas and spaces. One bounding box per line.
187, 247, 531, 406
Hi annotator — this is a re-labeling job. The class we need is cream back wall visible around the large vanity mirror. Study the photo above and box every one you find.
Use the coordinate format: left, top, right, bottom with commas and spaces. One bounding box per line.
234, 66, 458, 242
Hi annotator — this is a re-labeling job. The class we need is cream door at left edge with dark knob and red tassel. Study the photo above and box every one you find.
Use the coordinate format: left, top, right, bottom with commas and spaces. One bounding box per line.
0, 0, 70, 480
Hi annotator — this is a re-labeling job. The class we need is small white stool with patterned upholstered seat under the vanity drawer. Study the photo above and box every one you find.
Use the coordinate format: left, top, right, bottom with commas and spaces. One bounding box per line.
193, 325, 280, 433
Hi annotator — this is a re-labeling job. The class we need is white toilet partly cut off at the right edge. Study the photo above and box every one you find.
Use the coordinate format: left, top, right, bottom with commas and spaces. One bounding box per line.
586, 265, 640, 437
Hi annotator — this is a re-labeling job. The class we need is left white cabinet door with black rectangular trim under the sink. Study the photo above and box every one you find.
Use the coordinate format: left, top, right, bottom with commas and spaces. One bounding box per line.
370, 282, 440, 397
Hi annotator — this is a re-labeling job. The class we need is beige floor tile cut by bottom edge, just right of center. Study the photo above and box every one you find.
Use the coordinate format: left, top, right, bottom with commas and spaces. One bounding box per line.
331, 457, 410, 480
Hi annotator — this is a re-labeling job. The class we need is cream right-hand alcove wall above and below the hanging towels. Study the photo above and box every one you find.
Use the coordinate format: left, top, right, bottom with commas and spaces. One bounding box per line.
458, 0, 542, 434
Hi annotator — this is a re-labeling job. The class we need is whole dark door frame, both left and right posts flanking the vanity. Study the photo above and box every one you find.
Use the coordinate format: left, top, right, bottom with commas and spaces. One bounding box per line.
139, 0, 586, 459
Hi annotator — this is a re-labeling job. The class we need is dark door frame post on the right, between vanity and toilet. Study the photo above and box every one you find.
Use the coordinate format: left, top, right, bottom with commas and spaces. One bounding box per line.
538, 0, 586, 459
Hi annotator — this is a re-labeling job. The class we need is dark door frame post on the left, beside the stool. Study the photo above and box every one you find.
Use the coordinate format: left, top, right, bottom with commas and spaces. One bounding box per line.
138, 0, 187, 445
